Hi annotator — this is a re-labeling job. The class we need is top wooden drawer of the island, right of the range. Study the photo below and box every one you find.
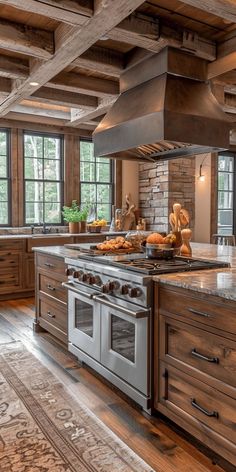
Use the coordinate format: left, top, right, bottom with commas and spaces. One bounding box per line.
159, 287, 236, 334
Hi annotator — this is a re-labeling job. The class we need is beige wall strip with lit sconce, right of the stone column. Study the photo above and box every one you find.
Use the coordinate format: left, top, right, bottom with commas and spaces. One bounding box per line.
194, 154, 211, 243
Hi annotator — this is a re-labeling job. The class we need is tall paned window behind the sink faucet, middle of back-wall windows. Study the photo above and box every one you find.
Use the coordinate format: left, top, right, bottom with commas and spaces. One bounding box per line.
24, 132, 63, 225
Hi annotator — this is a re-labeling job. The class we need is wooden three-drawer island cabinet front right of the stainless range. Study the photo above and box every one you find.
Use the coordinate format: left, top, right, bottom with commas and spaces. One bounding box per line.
154, 283, 236, 466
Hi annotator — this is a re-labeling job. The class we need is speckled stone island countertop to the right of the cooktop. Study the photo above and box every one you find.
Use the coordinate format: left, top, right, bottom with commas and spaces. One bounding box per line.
153, 243, 236, 302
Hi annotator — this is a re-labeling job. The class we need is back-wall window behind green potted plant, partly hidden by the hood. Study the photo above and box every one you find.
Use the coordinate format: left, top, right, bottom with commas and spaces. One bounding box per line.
80, 140, 113, 221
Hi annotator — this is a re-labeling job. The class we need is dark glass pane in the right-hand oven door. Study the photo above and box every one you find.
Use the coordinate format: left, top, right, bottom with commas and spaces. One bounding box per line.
111, 315, 135, 362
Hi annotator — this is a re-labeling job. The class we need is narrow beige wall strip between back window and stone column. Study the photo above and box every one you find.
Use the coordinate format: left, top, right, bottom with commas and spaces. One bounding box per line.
122, 161, 139, 208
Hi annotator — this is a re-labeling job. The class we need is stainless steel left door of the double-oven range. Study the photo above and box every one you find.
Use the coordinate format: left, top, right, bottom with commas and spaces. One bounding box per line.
65, 284, 101, 361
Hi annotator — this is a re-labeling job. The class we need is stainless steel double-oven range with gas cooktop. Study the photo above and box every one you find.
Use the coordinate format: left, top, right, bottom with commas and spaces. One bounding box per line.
64, 253, 227, 409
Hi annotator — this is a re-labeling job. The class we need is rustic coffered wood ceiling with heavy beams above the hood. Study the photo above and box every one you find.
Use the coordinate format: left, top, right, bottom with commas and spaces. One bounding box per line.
0, 0, 236, 130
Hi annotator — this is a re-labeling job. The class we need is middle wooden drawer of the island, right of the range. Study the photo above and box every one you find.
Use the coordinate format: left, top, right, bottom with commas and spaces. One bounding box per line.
160, 316, 236, 394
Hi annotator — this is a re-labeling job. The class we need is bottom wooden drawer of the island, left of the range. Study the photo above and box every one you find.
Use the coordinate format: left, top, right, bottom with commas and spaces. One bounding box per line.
39, 299, 67, 332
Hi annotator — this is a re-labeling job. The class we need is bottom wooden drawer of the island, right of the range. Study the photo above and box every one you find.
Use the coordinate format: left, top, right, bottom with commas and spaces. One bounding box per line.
160, 362, 236, 444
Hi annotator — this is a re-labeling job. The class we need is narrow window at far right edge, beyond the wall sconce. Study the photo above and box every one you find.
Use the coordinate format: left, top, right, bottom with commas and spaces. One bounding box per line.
217, 152, 236, 234
